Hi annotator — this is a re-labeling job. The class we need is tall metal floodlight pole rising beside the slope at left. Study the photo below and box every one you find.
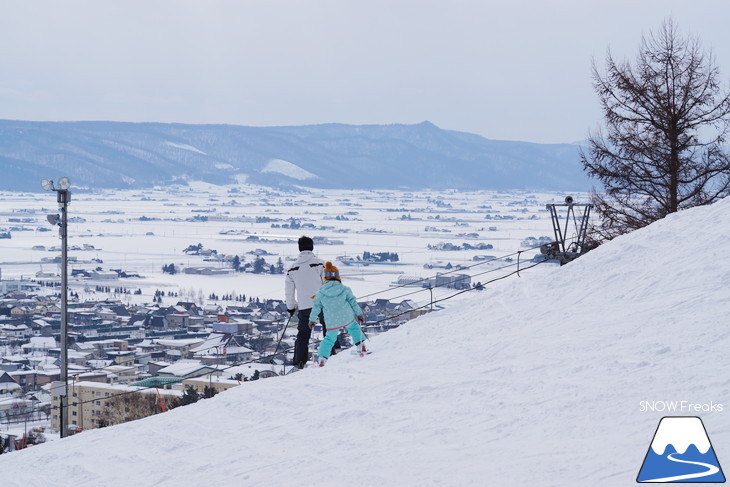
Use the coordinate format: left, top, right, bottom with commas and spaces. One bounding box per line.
41, 178, 71, 438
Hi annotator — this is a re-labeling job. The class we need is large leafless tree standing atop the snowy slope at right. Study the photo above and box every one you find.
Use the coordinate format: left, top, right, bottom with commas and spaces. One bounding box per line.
581, 20, 730, 238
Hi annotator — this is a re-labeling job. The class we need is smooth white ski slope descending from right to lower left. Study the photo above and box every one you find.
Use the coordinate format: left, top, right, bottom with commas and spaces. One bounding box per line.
0, 199, 730, 487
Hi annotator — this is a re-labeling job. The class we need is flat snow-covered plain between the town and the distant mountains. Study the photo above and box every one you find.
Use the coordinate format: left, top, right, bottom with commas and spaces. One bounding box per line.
0, 183, 587, 304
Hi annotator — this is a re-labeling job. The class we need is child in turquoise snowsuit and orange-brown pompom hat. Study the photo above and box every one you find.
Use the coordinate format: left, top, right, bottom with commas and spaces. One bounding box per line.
309, 262, 365, 366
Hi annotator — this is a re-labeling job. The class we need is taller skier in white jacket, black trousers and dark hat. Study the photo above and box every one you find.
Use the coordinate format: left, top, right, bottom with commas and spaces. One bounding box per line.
284, 237, 339, 369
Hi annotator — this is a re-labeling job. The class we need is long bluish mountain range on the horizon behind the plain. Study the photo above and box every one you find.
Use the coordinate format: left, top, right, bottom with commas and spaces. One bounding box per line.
0, 120, 592, 191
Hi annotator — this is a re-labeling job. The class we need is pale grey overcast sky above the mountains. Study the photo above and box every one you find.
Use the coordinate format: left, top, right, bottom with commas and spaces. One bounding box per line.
0, 0, 730, 143
